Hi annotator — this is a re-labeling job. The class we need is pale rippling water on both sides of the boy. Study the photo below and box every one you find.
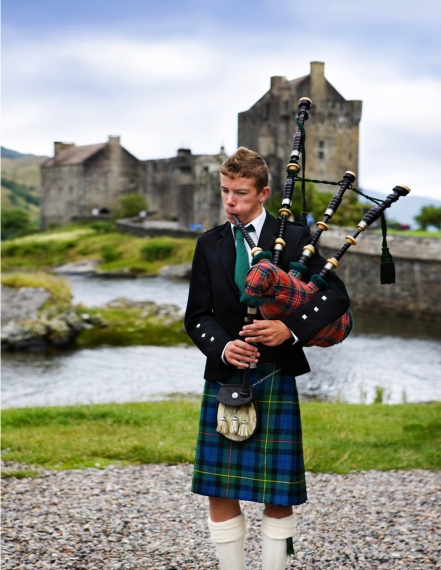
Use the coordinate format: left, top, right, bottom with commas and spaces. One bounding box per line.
2, 277, 441, 408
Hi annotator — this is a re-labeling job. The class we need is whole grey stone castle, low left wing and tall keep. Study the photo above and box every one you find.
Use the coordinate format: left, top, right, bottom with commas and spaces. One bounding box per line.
41, 61, 362, 229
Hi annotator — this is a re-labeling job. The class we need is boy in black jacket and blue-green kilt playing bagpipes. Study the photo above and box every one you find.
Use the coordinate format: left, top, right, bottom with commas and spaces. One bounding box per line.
185, 147, 349, 570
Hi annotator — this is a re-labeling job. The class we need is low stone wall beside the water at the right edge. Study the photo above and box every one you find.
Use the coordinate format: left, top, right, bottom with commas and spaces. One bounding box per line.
319, 228, 441, 321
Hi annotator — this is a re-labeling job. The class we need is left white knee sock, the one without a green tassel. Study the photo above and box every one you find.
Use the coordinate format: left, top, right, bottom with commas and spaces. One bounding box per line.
208, 513, 245, 570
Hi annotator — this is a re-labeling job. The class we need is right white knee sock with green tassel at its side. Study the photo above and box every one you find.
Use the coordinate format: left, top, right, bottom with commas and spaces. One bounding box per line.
262, 512, 295, 570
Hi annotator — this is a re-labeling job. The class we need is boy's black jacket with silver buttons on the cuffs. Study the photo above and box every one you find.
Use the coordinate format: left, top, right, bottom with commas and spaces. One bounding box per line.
185, 212, 349, 381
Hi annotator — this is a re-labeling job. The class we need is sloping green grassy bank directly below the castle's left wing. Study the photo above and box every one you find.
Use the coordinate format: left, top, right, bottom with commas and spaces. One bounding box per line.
2, 222, 196, 275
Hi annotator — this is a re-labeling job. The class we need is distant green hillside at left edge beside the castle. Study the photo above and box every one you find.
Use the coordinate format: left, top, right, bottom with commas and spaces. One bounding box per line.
1, 147, 48, 220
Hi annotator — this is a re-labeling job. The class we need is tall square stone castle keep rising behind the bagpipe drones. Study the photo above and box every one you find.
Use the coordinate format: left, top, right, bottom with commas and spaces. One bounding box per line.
238, 61, 362, 193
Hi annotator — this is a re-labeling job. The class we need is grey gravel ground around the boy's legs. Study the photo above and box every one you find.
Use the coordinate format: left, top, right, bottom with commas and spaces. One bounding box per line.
2, 465, 441, 570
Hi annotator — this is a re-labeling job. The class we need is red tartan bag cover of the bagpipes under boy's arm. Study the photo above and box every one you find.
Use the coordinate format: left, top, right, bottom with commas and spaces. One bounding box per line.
245, 260, 353, 347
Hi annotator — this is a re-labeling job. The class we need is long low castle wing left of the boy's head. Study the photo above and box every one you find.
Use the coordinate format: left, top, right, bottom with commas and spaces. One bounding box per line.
41, 137, 227, 230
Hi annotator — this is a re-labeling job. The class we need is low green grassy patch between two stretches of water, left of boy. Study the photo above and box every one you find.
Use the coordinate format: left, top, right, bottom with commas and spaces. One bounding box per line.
76, 307, 191, 348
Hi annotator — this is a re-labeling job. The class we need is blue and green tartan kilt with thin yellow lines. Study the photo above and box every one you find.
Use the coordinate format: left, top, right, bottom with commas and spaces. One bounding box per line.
191, 364, 307, 506
